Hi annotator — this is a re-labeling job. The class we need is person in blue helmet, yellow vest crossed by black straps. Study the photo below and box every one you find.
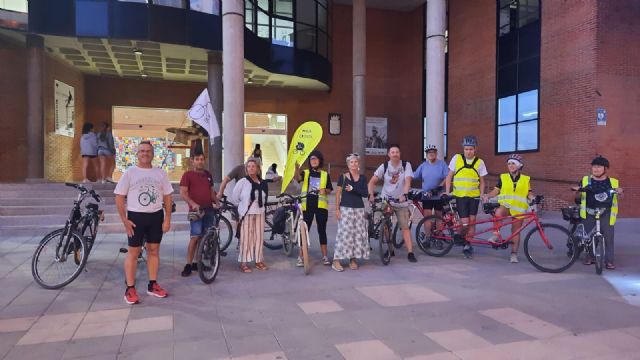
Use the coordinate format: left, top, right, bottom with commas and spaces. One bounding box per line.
445, 135, 488, 258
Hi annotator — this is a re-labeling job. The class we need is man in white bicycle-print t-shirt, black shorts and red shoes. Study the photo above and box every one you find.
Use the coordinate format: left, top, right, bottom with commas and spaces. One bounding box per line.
113, 141, 173, 305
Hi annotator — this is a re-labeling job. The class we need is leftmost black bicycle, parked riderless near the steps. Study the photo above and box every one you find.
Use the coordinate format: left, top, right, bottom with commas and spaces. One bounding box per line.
31, 183, 103, 289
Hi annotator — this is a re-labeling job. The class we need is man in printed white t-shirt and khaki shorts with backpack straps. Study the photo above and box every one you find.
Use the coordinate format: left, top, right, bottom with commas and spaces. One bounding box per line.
368, 144, 417, 262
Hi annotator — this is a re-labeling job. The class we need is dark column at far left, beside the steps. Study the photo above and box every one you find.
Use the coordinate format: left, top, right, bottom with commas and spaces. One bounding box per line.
27, 35, 44, 182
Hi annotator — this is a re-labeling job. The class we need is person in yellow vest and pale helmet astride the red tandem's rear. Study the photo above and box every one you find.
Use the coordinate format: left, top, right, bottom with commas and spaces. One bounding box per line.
482, 154, 535, 263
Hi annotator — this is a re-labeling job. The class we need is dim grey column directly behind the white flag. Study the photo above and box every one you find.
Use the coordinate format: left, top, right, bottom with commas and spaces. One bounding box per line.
207, 52, 224, 183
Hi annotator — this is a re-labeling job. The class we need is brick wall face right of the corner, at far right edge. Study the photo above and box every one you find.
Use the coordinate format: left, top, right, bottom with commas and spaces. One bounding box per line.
589, 0, 640, 216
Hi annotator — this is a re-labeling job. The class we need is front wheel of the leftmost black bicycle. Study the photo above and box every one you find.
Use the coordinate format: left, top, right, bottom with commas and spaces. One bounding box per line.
31, 229, 89, 289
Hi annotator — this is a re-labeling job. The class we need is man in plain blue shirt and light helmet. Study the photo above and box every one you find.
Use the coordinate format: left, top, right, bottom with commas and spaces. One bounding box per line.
414, 145, 449, 235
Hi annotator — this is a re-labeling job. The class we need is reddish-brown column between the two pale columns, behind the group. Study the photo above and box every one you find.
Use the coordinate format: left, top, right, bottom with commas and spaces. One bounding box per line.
353, 0, 367, 173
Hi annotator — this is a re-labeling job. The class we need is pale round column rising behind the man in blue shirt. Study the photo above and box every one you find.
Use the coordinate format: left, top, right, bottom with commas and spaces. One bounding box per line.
426, 0, 447, 156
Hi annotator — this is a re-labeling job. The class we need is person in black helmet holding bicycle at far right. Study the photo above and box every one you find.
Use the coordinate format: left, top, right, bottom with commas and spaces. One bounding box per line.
573, 155, 623, 270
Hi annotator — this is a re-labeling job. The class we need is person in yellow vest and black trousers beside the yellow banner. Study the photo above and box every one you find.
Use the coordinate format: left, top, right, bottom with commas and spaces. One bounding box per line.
296, 150, 333, 267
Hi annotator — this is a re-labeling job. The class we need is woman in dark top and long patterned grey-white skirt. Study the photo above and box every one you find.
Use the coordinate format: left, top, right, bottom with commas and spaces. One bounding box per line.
331, 153, 369, 271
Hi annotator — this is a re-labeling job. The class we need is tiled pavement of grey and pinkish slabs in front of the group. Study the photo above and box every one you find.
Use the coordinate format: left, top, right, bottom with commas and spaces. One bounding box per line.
0, 212, 640, 360
